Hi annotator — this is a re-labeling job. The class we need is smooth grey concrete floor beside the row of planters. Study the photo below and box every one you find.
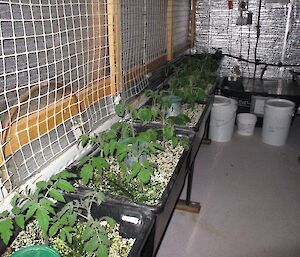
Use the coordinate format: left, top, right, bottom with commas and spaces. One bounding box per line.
157, 117, 300, 257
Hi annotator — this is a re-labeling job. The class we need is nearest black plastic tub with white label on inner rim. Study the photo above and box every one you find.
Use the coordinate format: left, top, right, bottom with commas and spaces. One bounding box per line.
0, 201, 154, 257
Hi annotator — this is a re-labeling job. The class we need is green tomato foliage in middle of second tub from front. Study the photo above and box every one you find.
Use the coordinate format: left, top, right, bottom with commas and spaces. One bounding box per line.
77, 127, 163, 185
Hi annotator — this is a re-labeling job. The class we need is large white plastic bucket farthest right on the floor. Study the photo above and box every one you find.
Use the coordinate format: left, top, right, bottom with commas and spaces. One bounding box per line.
262, 99, 295, 146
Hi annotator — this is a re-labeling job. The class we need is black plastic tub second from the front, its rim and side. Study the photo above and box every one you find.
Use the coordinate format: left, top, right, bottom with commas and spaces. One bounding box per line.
70, 128, 195, 257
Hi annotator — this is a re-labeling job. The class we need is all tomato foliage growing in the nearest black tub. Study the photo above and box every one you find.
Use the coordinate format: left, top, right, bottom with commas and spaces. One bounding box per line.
0, 171, 122, 257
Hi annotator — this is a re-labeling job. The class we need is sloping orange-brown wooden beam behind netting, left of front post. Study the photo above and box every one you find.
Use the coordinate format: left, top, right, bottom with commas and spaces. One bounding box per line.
0, 79, 111, 167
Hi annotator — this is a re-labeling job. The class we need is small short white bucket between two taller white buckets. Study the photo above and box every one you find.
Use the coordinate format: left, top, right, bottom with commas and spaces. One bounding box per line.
237, 113, 257, 136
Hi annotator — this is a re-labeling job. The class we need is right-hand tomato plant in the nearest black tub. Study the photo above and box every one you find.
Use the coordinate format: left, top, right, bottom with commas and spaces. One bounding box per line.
49, 188, 116, 257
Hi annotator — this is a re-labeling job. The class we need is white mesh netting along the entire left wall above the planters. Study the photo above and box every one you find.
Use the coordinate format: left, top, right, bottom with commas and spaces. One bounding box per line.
0, 0, 189, 198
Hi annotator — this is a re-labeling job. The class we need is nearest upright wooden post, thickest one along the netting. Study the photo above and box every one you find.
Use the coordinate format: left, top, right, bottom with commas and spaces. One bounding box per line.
107, 0, 123, 95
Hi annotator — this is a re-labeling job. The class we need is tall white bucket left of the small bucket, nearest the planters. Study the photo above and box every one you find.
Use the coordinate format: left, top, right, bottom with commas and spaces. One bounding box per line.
209, 96, 237, 142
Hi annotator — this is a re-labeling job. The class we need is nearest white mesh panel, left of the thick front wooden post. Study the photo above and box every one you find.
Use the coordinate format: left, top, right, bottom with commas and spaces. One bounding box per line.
0, 0, 121, 193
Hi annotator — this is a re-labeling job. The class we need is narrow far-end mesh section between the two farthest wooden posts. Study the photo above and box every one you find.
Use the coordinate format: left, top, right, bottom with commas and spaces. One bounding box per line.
173, 0, 191, 56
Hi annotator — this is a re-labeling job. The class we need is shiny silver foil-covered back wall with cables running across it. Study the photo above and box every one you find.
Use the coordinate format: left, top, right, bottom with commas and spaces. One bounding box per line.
194, 0, 300, 78
